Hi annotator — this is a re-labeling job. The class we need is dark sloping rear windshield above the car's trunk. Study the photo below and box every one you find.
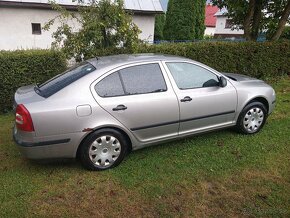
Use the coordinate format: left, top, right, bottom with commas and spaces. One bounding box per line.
35, 62, 96, 98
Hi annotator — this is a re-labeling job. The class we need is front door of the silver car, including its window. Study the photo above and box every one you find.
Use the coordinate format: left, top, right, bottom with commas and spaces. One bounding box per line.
164, 62, 237, 135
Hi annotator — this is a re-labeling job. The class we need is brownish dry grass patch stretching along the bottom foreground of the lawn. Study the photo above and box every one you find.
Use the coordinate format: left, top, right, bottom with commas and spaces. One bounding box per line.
29, 170, 289, 217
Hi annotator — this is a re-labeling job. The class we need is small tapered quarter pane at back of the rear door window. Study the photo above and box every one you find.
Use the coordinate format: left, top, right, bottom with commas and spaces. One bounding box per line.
95, 72, 125, 97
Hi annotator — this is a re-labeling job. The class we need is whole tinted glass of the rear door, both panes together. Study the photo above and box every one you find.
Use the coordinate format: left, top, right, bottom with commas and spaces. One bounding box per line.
95, 64, 167, 97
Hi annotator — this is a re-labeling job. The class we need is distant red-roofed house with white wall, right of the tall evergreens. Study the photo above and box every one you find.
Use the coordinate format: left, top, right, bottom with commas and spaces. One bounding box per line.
204, 4, 219, 36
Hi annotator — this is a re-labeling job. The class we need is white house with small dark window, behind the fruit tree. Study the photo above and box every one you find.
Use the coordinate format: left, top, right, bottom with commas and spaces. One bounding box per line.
0, 0, 163, 50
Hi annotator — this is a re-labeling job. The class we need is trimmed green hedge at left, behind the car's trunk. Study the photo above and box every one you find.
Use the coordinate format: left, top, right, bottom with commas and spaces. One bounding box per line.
0, 50, 66, 113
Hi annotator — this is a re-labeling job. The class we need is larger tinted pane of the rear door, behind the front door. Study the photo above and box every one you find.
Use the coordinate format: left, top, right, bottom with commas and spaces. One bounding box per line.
120, 64, 167, 95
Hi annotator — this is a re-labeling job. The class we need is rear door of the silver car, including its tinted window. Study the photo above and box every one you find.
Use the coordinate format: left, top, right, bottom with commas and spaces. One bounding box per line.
94, 62, 179, 142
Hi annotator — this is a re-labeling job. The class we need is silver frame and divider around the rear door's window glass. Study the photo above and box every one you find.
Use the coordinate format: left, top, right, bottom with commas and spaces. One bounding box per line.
91, 61, 168, 98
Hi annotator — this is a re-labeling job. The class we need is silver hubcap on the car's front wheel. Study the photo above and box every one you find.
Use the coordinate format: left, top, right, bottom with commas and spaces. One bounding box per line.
243, 107, 264, 133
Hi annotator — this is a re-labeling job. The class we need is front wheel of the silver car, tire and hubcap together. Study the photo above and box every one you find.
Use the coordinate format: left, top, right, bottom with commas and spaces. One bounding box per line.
236, 102, 268, 134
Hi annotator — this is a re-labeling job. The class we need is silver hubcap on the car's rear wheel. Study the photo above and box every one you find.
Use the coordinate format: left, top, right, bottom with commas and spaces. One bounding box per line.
89, 135, 121, 168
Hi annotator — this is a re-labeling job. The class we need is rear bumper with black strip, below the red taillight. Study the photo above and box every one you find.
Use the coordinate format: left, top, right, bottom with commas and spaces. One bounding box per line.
13, 128, 78, 160
